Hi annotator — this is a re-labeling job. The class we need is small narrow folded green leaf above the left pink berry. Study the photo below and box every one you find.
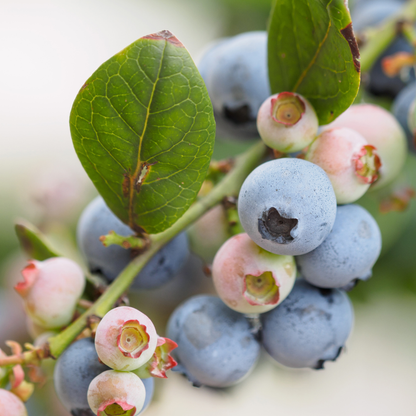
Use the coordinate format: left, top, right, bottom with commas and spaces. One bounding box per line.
15, 220, 61, 261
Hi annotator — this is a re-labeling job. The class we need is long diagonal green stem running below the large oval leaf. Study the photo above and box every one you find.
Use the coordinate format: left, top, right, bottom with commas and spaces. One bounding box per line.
49, 142, 266, 357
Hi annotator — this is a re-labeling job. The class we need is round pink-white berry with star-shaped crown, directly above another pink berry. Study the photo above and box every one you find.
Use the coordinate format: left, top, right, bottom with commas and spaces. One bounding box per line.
95, 306, 158, 371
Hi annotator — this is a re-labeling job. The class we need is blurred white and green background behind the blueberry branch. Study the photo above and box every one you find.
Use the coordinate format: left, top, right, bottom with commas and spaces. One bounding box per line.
0, 0, 416, 416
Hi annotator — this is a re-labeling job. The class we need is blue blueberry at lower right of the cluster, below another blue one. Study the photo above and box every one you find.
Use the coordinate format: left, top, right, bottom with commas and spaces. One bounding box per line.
260, 279, 354, 369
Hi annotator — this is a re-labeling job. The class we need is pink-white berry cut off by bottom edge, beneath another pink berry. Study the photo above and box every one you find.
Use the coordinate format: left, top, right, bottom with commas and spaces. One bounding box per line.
88, 370, 146, 416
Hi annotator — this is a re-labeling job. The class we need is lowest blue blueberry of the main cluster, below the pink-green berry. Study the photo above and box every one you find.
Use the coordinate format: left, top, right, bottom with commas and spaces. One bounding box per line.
167, 295, 260, 387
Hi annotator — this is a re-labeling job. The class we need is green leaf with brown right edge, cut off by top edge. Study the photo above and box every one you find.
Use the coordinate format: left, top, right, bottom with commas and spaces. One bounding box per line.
268, 0, 360, 124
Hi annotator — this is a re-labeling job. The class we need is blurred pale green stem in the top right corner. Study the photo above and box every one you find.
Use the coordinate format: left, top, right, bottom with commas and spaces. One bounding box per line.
360, 0, 416, 72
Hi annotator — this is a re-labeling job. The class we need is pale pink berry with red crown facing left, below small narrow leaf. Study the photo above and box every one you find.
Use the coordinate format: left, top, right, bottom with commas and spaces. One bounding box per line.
15, 257, 85, 328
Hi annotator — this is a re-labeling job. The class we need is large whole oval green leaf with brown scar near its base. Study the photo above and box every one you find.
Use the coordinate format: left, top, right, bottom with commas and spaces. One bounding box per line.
70, 31, 215, 234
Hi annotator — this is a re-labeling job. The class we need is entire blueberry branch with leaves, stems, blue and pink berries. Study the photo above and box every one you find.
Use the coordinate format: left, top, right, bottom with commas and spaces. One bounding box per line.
0, 0, 416, 416
